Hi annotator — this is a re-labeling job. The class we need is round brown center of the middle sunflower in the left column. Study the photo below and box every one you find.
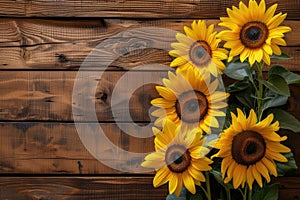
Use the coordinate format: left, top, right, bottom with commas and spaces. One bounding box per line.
175, 90, 208, 123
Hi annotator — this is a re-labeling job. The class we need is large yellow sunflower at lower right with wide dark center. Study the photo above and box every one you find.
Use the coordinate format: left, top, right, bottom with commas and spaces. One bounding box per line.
214, 109, 290, 190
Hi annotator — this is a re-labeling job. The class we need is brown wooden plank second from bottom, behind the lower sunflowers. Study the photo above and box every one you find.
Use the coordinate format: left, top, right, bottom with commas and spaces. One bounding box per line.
0, 122, 300, 176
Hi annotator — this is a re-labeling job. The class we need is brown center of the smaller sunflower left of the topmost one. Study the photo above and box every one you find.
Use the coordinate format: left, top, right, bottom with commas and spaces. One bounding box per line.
189, 40, 212, 67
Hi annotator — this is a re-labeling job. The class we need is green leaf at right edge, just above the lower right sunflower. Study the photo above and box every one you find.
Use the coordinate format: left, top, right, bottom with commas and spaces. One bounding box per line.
268, 109, 300, 133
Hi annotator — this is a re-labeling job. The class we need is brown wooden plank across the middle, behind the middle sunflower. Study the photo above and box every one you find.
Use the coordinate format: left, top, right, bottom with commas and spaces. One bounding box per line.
0, 71, 300, 122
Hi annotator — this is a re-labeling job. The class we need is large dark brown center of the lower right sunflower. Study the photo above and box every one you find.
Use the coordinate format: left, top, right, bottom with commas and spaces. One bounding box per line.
231, 131, 266, 166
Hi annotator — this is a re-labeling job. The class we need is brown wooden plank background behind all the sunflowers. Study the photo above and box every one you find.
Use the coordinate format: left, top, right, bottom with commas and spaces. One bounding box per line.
0, 0, 300, 200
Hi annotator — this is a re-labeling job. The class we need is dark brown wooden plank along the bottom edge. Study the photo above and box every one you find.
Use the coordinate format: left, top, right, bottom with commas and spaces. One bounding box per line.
0, 177, 168, 200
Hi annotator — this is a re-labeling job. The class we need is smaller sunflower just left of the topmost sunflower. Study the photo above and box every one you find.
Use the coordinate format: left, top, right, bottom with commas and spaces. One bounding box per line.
169, 20, 227, 77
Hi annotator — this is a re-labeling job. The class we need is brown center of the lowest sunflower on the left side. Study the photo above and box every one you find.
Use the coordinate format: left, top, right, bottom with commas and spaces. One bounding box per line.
165, 144, 191, 173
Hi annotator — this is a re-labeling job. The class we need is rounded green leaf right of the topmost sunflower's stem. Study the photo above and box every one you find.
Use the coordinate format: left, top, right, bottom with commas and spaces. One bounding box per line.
262, 74, 290, 96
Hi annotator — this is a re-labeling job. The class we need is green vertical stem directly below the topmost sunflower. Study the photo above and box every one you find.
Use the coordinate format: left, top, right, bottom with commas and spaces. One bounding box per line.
256, 63, 264, 121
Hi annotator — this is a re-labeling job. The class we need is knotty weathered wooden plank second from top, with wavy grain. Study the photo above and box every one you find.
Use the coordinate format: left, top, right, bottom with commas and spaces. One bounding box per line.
0, 19, 300, 70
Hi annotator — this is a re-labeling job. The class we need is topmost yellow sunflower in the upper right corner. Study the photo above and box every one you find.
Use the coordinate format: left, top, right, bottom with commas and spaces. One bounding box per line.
217, 0, 291, 66
